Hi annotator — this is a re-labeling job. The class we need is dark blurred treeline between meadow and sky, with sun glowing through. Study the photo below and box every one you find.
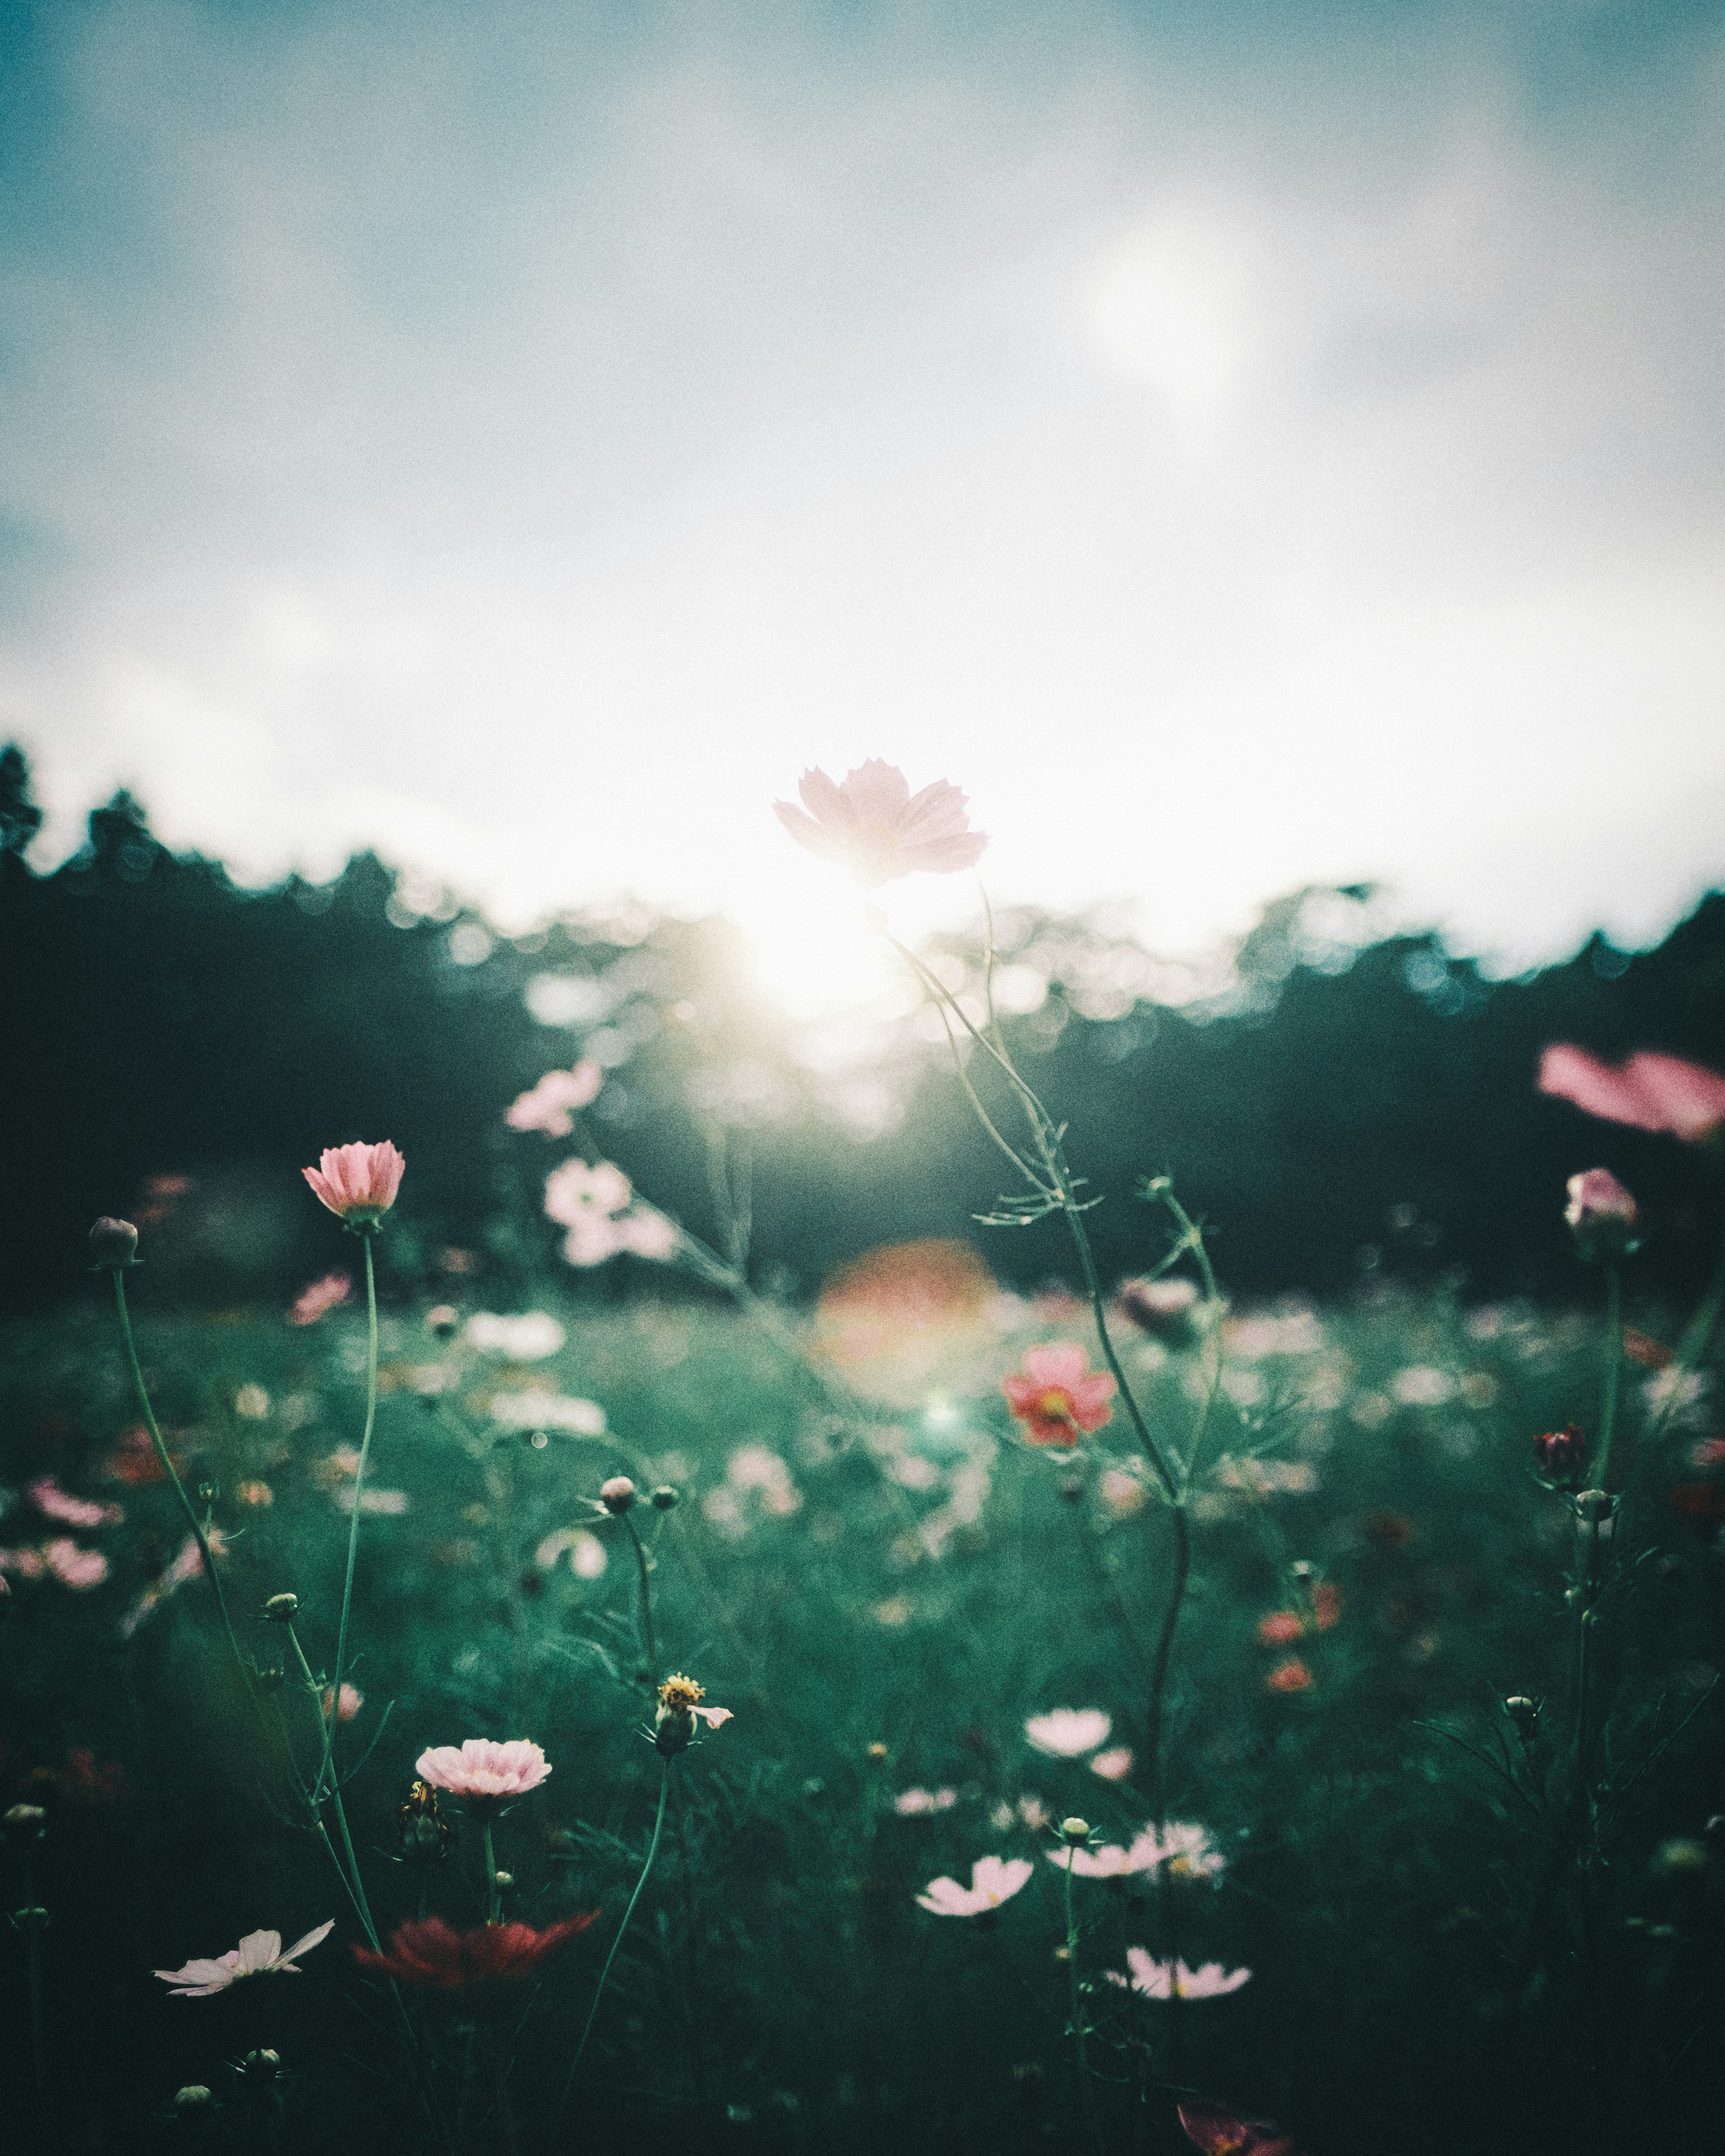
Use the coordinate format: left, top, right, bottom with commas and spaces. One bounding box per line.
0, 750, 1725, 1311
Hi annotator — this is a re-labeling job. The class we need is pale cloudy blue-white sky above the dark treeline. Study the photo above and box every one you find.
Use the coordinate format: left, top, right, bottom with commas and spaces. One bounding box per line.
0, 0, 1725, 994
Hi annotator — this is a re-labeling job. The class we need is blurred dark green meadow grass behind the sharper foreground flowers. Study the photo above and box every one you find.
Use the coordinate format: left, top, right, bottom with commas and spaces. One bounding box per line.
0, 1274, 1725, 2156
